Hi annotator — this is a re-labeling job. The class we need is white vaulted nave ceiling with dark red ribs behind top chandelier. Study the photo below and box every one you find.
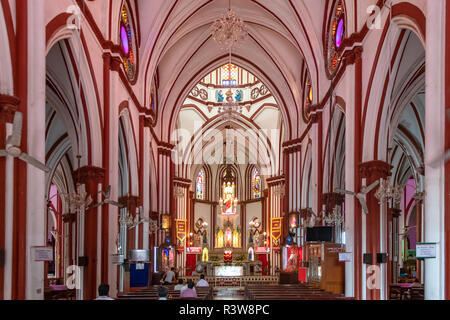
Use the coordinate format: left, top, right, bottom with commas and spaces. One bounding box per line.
138, 0, 326, 139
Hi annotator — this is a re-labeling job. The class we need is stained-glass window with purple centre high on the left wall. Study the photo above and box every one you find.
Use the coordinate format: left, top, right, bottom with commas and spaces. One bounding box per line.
119, 2, 137, 82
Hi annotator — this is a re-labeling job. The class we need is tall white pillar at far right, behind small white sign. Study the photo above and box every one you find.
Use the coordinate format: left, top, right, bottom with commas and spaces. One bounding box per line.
425, 0, 448, 300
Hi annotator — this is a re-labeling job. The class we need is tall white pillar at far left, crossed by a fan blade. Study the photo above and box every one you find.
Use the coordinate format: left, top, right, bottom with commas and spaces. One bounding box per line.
26, 0, 46, 300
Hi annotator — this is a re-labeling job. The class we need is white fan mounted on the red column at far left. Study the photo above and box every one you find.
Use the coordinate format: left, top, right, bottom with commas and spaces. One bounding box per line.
0, 112, 50, 172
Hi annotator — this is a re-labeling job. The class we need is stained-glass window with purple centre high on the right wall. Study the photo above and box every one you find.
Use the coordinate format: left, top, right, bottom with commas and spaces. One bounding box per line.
327, 0, 346, 76
